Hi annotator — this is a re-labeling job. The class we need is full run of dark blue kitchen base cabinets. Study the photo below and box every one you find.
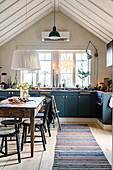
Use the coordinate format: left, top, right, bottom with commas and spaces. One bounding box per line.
0, 90, 112, 124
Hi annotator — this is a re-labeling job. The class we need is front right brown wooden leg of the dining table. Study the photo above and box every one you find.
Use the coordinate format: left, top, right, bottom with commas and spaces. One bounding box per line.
30, 111, 35, 157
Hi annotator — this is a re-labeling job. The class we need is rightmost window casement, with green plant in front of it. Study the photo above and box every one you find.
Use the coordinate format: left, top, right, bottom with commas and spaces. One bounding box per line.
75, 53, 90, 87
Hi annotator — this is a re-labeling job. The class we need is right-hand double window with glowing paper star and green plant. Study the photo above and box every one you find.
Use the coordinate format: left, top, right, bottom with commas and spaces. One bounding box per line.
60, 51, 90, 87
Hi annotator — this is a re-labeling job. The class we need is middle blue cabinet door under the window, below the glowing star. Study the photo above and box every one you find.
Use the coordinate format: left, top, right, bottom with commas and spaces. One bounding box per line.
65, 95, 78, 117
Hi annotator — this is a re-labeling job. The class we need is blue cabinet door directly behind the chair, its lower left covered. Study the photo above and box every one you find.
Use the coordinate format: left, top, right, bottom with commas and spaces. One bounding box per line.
54, 95, 65, 117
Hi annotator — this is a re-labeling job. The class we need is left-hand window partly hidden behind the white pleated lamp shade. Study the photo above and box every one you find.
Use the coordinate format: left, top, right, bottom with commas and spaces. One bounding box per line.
22, 52, 52, 86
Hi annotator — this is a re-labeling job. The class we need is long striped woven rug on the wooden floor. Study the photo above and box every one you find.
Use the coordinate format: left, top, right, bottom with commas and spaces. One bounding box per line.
52, 124, 111, 170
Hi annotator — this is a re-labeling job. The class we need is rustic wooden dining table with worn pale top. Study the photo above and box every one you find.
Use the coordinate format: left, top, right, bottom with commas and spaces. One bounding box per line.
0, 97, 45, 157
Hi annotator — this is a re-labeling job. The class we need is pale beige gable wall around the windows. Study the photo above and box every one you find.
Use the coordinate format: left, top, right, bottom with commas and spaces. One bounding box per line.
0, 12, 112, 86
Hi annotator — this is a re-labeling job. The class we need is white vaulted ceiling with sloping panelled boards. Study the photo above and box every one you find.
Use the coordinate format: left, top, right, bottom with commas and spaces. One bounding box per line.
0, 0, 113, 46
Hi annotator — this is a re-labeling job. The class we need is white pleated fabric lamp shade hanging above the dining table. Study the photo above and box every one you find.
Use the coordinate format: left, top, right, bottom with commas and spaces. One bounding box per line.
11, 50, 40, 70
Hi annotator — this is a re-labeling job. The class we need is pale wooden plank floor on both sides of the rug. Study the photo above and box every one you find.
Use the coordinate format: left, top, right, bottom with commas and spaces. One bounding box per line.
0, 122, 112, 170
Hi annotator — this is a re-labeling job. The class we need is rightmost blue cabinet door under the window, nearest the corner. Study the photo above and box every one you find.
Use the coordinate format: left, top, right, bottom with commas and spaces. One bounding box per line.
79, 94, 92, 117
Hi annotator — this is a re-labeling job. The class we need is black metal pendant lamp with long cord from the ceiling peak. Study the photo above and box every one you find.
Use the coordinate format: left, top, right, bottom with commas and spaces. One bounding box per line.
49, 0, 60, 39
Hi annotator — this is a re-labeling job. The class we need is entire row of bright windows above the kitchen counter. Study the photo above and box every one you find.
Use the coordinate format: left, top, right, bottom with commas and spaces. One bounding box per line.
21, 51, 91, 87
